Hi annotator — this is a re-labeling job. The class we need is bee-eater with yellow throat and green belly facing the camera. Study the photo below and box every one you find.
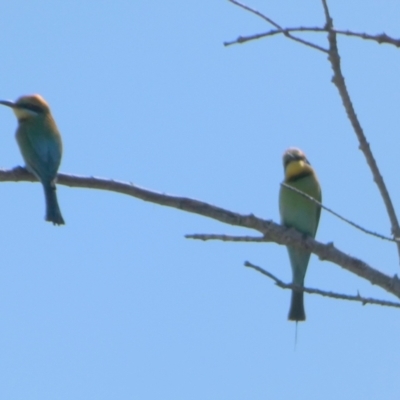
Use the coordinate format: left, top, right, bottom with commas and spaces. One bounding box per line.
279, 148, 322, 321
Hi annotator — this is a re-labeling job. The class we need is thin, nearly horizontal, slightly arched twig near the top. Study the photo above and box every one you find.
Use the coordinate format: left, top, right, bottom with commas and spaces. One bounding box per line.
224, 26, 400, 48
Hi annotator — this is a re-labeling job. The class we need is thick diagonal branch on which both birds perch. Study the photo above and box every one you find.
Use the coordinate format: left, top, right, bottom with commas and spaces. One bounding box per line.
0, 167, 400, 298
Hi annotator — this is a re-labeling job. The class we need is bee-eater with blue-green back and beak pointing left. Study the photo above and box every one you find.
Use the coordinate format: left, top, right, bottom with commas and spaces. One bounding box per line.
0, 94, 64, 225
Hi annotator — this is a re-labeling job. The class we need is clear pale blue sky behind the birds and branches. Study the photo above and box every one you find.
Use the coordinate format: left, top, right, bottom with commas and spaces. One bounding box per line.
0, 0, 400, 400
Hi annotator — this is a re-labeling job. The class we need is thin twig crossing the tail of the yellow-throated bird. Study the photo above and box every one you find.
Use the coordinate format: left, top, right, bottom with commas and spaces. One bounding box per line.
244, 261, 400, 308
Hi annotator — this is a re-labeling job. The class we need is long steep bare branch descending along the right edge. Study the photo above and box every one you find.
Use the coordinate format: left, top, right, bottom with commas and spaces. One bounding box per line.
322, 0, 400, 256
